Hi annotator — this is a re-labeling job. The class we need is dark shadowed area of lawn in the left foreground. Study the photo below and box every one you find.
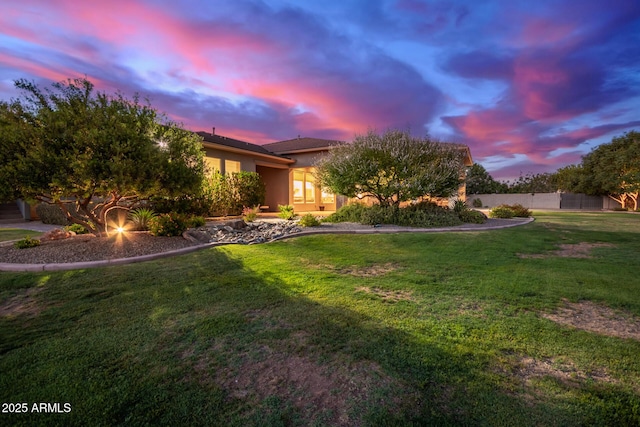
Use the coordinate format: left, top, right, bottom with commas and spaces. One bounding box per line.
0, 249, 636, 426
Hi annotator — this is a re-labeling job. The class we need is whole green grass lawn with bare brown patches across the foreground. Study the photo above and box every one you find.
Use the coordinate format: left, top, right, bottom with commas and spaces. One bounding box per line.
0, 212, 640, 426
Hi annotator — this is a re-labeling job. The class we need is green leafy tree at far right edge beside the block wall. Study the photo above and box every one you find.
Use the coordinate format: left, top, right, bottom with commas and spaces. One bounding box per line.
580, 131, 640, 210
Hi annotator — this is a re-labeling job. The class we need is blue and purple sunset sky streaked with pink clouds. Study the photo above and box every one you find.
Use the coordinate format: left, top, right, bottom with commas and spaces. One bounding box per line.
0, 0, 640, 179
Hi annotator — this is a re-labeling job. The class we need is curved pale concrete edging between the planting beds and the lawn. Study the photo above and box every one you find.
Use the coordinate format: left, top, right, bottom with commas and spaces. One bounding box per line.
0, 217, 534, 272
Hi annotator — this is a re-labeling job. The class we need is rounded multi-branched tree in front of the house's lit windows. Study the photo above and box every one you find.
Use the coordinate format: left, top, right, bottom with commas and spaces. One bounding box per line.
316, 130, 463, 206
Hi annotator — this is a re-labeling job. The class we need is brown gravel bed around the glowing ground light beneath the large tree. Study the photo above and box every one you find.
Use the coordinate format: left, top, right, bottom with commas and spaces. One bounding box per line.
0, 232, 196, 264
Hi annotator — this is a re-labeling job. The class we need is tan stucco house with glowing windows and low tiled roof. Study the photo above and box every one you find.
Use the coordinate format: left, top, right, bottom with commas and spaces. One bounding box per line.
197, 128, 346, 212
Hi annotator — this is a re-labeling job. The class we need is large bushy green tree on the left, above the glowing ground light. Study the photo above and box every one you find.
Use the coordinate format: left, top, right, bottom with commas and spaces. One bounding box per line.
0, 79, 204, 234
